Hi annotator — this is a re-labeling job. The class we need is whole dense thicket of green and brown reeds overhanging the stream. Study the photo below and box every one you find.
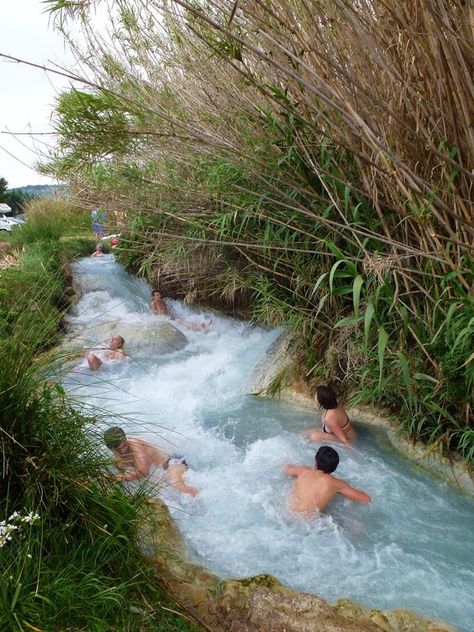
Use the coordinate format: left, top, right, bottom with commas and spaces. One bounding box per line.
43, 0, 474, 462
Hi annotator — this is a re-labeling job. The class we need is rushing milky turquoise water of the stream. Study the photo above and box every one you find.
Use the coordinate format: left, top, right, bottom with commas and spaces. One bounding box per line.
66, 256, 474, 632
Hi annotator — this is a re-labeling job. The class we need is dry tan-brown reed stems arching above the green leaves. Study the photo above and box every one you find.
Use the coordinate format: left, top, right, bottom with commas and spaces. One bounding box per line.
50, 0, 474, 287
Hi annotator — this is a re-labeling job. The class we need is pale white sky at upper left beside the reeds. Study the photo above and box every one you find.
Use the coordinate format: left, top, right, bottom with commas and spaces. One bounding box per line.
0, 0, 76, 188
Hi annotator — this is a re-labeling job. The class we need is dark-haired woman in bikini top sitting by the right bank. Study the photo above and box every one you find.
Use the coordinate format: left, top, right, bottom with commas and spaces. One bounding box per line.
303, 386, 356, 445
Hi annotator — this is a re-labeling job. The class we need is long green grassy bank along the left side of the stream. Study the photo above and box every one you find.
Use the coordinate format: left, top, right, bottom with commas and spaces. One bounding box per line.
0, 201, 201, 632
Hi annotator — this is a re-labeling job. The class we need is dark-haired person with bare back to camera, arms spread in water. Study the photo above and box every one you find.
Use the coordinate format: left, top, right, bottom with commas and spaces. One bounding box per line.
283, 445, 371, 518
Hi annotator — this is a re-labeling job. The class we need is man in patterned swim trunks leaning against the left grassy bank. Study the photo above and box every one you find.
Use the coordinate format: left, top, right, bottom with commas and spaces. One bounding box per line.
104, 426, 198, 496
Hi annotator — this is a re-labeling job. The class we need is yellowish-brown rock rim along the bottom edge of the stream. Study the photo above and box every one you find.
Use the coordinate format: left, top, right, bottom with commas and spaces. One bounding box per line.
142, 499, 457, 632
